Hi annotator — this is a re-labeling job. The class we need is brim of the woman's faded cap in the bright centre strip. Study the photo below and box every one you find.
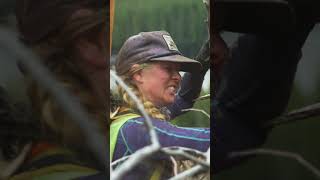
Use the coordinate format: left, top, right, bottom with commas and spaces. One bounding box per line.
150, 55, 202, 72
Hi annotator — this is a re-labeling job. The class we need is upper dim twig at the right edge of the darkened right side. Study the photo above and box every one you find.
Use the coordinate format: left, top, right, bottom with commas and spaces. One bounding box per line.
265, 103, 320, 127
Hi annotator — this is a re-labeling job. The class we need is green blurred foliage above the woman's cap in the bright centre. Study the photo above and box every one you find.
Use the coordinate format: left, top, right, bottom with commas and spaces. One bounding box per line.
112, 0, 207, 57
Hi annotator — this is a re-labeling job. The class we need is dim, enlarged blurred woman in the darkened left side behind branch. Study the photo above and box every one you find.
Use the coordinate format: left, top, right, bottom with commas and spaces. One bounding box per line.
5, 0, 109, 179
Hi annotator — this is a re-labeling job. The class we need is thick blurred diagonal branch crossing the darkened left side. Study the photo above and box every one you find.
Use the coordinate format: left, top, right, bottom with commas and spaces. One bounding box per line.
0, 28, 107, 170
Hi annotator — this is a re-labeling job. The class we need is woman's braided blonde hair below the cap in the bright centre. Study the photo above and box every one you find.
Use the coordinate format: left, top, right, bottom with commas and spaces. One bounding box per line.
110, 63, 167, 120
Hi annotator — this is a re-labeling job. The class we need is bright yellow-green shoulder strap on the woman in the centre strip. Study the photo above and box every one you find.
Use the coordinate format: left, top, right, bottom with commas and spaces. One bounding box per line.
110, 113, 140, 161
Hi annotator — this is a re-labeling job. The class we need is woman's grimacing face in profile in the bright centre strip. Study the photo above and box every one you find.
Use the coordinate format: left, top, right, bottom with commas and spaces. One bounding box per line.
133, 62, 181, 107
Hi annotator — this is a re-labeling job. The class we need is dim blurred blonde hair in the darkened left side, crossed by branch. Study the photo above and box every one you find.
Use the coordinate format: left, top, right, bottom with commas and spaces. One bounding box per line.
26, 12, 107, 149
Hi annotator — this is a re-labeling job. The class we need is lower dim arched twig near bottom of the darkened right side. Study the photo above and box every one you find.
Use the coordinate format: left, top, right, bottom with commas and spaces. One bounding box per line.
229, 149, 320, 179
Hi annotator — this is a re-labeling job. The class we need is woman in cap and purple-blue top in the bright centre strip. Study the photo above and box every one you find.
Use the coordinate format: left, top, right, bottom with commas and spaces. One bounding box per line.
110, 31, 210, 179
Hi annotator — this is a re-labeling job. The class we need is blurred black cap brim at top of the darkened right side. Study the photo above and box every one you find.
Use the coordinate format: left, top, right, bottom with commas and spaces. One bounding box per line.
213, 0, 295, 33
